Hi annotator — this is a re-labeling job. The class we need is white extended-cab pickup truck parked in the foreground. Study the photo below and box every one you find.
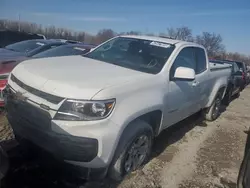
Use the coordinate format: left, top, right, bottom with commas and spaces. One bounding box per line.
5, 36, 231, 180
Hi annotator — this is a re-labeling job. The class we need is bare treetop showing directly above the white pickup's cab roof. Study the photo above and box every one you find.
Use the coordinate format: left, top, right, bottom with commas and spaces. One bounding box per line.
167, 26, 193, 41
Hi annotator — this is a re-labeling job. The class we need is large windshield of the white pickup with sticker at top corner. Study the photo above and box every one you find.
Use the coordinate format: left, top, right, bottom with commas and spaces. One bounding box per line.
85, 37, 175, 74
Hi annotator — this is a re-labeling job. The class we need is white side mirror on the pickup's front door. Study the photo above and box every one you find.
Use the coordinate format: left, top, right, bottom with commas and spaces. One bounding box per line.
174, 67, 195, 80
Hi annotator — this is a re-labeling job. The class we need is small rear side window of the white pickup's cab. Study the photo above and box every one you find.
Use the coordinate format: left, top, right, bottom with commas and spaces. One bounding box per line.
195, 48, 207, 74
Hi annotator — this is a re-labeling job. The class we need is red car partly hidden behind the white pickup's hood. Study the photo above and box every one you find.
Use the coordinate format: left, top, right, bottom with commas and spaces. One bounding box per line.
0, 42, 95, 107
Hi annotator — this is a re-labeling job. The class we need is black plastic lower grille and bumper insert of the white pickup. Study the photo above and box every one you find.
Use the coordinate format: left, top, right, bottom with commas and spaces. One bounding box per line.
6, 101, 98, 162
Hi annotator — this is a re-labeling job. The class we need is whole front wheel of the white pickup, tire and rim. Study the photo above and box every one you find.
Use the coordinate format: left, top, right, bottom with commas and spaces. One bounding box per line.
109, 120, 153, 181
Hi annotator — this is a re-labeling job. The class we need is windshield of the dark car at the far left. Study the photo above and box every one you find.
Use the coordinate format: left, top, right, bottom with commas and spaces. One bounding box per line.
5, 40, 45, 53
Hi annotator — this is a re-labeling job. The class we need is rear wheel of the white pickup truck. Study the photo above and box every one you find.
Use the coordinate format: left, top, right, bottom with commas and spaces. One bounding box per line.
205, 93, 221, 121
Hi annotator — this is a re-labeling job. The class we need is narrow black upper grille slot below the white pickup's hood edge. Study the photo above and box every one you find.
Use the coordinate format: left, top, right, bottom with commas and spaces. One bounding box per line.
10, 74, 63, 104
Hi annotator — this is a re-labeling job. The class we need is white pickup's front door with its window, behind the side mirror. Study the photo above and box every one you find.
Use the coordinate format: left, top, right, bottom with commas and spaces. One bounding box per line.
164, 47, 199, 127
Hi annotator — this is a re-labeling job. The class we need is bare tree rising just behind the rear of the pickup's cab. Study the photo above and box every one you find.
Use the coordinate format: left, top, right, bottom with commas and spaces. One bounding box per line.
195, 32, 225, 56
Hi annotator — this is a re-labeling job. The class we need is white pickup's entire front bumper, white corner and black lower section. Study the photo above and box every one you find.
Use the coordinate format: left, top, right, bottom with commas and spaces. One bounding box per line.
6, 87, 119, 169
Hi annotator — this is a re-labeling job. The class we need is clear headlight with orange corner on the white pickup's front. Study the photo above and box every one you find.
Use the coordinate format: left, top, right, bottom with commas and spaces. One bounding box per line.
54, 99, 115, 121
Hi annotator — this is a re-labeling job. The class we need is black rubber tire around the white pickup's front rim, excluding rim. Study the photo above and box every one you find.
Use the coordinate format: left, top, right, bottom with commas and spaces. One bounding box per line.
108, 120, 153, 181
